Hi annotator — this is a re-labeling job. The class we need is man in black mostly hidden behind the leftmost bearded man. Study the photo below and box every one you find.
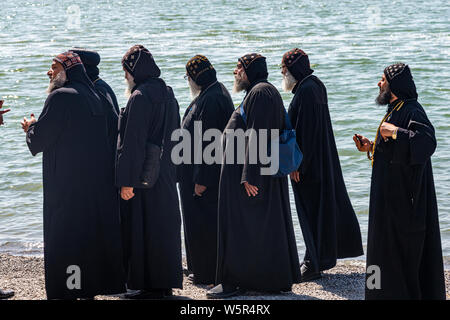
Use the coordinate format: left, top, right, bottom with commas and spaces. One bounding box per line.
70, 48, 119, 150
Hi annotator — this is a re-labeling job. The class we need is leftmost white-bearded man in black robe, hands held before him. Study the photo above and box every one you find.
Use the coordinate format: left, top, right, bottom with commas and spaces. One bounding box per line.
22, 52, 125, 299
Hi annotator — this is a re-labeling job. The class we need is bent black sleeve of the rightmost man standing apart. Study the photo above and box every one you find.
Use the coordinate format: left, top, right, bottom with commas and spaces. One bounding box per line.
392, 110, 436, 165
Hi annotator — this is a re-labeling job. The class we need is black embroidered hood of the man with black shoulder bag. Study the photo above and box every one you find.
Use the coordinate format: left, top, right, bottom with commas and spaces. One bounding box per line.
122, 44, 161, 84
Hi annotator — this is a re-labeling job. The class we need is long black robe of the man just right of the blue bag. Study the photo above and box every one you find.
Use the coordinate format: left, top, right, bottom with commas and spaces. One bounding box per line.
289, 75, 364, 272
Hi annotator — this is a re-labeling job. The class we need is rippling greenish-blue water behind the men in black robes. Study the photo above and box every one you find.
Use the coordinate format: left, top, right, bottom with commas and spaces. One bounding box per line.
0, 0, 450, 265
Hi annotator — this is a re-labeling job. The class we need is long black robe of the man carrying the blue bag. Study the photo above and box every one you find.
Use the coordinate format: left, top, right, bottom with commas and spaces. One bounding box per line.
216, 81, 300, 291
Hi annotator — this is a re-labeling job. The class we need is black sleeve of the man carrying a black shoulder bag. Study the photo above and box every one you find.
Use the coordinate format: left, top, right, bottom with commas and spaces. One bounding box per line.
116, 93, 150, 187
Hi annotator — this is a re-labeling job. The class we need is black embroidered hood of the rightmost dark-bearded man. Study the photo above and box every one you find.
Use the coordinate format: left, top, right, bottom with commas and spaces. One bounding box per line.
384, 63, 418, 100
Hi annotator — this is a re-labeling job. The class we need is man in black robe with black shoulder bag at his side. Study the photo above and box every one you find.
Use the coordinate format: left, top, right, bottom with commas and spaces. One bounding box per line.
116, 45, 183, 299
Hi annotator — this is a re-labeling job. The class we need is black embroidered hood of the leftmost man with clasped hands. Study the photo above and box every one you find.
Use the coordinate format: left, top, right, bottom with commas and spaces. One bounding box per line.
53, 51, 104, 115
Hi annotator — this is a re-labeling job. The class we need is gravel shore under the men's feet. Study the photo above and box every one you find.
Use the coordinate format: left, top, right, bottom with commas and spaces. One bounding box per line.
0, 254, 450, 300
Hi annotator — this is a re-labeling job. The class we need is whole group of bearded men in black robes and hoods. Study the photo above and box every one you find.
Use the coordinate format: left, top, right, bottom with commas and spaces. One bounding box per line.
14, 45, 445, 299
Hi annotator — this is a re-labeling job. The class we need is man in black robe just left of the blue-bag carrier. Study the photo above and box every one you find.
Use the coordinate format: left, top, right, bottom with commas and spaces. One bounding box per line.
178, 55, 234, 284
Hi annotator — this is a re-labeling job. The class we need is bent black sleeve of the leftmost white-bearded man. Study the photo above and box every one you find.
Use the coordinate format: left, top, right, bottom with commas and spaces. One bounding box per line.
26, 92, 68, 156
